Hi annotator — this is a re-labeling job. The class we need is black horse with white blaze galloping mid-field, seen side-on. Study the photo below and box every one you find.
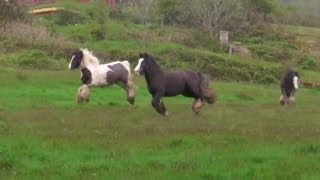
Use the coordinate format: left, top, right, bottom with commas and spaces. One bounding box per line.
134, 53, 215, 115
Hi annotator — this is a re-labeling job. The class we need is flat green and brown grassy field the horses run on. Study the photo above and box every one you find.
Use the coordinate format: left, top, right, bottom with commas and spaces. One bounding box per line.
0, 68, 320, 179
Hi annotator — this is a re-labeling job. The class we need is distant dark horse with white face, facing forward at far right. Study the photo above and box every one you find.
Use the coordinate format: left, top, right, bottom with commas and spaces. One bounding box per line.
280, 69, 299, 105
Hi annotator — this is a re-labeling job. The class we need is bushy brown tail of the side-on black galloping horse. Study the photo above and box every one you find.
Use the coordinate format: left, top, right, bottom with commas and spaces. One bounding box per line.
198, 73, 216, 104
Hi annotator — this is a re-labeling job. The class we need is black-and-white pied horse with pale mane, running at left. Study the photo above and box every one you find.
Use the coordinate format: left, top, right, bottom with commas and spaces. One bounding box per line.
68, 49, 135, 105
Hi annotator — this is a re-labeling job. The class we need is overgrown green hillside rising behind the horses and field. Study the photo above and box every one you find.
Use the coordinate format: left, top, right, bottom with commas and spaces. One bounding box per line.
0, 1, 320, 83
